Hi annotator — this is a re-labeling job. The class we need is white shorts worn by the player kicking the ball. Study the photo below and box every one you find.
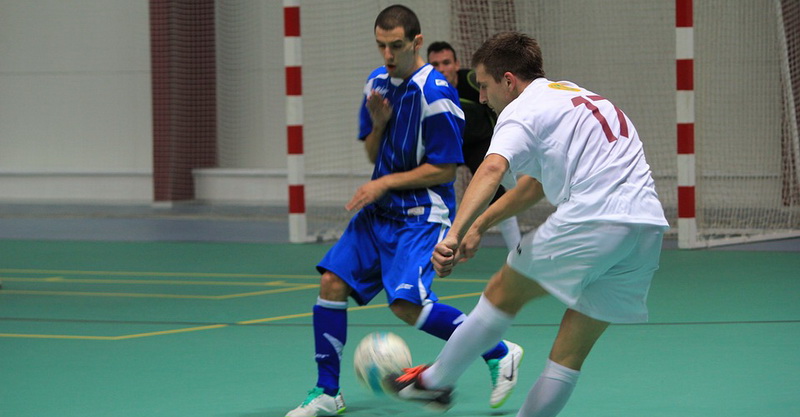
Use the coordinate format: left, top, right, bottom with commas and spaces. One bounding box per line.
507, 218, 666, 323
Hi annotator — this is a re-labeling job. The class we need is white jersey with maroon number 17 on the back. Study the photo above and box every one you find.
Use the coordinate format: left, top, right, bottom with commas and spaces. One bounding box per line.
487, 78, 668, 226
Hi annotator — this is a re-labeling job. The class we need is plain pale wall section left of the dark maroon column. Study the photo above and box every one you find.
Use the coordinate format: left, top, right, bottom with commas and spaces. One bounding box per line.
0, 0, 153, 201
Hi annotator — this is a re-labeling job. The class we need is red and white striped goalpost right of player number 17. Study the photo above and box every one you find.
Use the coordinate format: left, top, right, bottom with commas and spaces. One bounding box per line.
675, 0, 697, 248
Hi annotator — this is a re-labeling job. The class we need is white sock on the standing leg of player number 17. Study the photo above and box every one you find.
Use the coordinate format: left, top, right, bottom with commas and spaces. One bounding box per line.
517, 359, 581, 417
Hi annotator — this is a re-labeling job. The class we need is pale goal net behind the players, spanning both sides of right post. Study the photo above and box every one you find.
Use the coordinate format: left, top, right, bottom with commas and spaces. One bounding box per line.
282, 0, 800, 246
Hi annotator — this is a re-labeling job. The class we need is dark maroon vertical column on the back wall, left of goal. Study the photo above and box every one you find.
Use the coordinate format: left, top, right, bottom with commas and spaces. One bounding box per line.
150, 0, 217, 201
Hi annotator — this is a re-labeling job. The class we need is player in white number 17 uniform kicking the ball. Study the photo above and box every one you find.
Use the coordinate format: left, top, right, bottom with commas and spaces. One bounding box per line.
394, 32, 668, 417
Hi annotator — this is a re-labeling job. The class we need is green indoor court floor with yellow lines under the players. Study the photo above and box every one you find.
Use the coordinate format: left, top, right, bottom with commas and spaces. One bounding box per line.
0, 240, 800, 417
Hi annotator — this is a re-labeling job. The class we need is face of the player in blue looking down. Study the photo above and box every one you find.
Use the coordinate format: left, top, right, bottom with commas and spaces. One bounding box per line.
375, 27, 422, 79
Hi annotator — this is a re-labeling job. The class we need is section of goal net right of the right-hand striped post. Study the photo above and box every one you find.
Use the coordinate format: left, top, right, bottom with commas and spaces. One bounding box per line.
694, 0, 800, 246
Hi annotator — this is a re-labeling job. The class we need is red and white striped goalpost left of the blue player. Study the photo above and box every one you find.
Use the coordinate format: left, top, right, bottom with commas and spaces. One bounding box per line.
283, 0, 308, 243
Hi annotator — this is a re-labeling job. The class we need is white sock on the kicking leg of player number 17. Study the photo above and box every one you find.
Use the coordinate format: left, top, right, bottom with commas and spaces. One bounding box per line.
422, 295, 514, 388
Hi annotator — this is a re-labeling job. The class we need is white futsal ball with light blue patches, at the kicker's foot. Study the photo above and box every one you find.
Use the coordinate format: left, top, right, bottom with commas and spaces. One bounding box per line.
353, 332, 411, 395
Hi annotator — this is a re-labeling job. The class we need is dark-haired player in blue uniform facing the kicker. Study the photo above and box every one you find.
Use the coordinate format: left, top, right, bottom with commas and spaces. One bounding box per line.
287, 5, 523, 417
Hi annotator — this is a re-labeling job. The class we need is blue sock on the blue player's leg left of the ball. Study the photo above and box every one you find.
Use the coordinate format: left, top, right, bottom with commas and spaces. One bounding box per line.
313, 299, 347, 396
